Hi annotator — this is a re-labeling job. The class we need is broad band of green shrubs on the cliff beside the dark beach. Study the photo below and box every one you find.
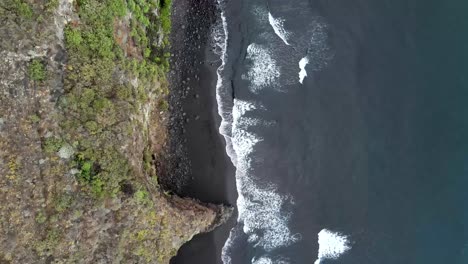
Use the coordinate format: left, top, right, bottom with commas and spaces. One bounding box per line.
58, 0, 170, 198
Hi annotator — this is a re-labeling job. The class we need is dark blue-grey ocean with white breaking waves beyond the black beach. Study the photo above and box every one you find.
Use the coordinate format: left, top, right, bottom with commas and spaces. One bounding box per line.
214, 0, 468, 264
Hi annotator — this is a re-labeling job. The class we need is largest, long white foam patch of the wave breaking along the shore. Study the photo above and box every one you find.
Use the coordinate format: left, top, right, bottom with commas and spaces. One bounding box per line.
232, 99, 298, 251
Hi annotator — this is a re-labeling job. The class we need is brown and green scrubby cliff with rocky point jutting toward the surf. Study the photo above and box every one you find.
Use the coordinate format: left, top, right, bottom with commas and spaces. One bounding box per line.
0, 0, 230, 263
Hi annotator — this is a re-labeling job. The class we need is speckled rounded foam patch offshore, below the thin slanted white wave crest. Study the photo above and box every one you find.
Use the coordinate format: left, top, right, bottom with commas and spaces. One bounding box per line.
243, 43, 281, 92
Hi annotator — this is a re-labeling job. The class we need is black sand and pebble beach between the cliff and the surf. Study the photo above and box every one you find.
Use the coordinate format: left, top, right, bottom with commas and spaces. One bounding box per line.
166, 0, 237, 264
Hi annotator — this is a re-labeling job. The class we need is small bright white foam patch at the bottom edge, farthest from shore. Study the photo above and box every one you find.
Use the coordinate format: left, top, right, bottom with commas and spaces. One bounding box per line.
314, 229, 351, 264
